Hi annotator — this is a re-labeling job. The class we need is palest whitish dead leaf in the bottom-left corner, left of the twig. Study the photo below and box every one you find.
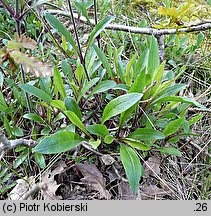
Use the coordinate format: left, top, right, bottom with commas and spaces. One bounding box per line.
9, 176, 35, 200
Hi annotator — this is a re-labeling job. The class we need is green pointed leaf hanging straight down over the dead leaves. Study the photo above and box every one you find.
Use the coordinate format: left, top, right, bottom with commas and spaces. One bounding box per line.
120, 144, 143, 193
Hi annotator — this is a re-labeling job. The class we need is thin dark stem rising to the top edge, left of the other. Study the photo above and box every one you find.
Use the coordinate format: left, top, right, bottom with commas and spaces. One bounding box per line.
67, 0, 90, 81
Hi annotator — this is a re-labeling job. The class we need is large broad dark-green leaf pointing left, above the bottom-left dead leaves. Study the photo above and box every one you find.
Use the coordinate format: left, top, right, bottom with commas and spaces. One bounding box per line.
33, 131, 84, 154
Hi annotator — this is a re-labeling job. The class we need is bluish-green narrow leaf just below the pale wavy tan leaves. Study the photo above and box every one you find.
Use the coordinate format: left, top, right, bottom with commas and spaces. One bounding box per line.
20, 84, 52, 104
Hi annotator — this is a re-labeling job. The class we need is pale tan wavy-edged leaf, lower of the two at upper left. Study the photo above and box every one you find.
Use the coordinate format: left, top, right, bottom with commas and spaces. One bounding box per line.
10, 50, 53, 77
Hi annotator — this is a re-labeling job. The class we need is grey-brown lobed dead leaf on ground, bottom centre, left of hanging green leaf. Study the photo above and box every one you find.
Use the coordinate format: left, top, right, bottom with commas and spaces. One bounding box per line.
76, 163, 111, 200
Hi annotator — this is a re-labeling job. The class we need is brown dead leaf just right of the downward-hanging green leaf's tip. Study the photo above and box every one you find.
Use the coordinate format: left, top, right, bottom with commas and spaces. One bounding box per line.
144, 156, 160, 177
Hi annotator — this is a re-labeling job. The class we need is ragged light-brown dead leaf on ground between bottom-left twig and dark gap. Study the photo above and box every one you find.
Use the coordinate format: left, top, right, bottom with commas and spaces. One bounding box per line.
42, 161, 67, 200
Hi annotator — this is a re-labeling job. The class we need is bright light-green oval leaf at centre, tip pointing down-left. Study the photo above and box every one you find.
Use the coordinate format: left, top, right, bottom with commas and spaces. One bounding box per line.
102, 93, 142, 123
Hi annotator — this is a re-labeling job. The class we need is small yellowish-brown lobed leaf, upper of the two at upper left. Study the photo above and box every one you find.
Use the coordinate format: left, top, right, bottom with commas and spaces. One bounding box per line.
8, 33, 37, 50
